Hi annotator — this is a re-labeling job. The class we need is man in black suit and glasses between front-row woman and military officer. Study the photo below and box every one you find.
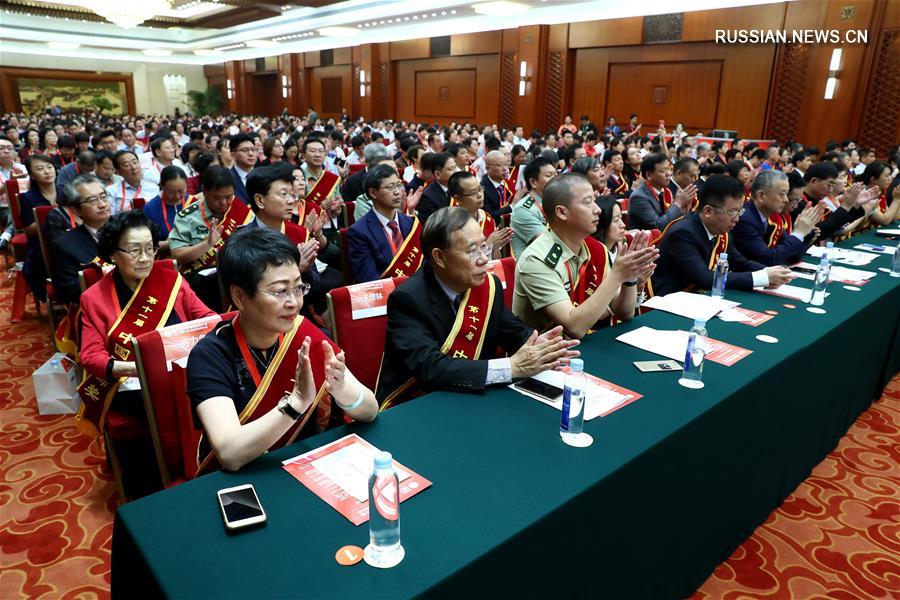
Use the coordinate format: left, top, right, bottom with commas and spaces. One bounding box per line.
376, 207, 579, 409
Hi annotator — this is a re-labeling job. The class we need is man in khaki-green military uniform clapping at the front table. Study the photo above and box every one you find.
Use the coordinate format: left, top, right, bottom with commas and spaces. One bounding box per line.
513, 173, 659, 338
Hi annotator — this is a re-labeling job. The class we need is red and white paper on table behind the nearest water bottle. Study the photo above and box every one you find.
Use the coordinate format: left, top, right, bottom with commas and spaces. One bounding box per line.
282, 433, 431, 525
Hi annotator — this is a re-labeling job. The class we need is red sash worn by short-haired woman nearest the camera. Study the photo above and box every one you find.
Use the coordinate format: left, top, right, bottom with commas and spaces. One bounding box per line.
197, 315, 340, 474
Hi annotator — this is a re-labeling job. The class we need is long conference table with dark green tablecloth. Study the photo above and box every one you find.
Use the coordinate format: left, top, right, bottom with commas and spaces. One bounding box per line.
111, 233, 900, 599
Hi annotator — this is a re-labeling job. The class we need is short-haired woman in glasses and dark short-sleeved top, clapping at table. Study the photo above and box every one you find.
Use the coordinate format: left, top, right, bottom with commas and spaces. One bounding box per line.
187, 227, 378, 472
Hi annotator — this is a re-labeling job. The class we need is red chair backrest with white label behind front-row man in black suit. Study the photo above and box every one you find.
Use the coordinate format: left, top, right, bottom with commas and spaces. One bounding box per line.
328, 277, 406, 390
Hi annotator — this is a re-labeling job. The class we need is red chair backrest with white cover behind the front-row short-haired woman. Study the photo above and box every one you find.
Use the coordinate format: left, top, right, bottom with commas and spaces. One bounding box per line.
134, 313, 236, 487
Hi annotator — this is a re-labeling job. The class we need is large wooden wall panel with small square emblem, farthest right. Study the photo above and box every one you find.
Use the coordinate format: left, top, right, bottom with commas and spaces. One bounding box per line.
606, 60, 724, 131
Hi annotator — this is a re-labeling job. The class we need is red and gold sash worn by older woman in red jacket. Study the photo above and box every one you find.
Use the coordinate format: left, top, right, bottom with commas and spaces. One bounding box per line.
75, 263, 183, 437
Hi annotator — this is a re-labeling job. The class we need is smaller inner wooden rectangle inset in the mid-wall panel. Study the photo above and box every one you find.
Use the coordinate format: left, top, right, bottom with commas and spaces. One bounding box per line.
415, 69, 477, 121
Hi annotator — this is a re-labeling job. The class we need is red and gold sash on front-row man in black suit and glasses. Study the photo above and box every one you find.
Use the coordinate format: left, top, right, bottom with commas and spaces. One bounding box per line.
380, 273, 496, 410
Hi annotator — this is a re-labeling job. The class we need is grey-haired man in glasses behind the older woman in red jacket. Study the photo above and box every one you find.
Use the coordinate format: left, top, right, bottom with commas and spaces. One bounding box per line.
52, 173, 112, 303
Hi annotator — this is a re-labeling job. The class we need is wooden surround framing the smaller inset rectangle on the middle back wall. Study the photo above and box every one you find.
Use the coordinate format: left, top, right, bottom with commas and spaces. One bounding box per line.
392, 55, 500, 123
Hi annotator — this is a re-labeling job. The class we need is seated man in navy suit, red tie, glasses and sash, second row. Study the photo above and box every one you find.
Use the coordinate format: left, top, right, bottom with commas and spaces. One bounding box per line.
347, 164, 422, 283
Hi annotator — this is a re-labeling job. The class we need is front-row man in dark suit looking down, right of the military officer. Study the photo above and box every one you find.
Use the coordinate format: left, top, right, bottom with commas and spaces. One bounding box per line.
651, 175, 793, 296
